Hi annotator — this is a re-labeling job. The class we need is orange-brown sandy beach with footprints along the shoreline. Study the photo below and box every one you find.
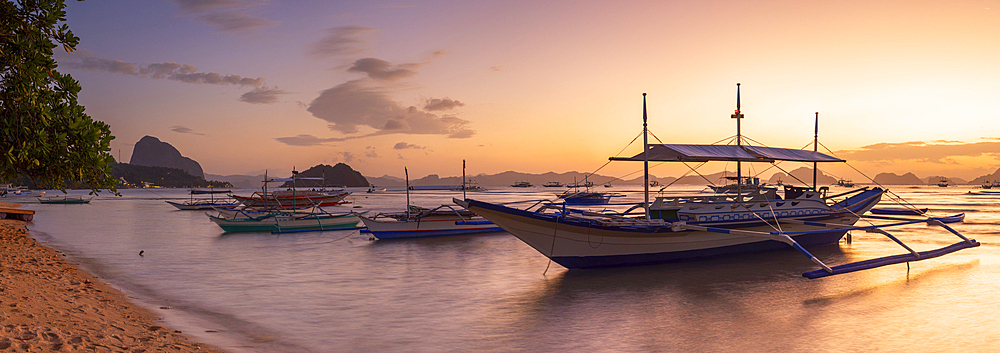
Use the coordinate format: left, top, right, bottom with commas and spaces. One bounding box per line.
0, 203, 225, 352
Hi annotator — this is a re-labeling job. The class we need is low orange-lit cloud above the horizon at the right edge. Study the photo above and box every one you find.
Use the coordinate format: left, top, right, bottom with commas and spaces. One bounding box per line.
835, 141, 1000, 164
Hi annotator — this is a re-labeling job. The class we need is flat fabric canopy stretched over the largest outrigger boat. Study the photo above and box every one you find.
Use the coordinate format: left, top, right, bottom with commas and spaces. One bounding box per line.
609, 144, 845, 163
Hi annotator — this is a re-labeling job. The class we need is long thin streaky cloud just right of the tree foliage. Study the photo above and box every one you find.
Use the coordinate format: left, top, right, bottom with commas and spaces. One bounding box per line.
59, 51, 264, 87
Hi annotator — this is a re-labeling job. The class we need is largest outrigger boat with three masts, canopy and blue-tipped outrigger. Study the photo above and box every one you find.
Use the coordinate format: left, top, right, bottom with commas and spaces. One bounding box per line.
454, 84, 979, 278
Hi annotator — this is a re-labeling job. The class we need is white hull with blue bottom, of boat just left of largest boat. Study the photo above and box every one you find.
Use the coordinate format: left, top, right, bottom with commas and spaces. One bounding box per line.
359, 212, 503, 239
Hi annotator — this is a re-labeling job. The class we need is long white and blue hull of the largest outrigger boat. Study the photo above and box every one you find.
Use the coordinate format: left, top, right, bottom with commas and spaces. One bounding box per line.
459, 190, 878, 268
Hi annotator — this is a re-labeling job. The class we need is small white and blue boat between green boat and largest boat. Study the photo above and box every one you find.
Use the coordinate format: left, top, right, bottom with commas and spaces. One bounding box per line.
358, 205, 503, 239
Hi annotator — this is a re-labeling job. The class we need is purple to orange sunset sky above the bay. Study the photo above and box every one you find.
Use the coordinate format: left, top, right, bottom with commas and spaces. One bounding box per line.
56, 0, 1000, 181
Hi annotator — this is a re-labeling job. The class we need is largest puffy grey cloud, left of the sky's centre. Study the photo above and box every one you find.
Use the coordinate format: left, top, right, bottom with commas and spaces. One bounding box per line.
307, 80, 475, 140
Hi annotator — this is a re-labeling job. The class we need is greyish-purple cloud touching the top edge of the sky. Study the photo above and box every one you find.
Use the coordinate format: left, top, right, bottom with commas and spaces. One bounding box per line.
174, 0, 278, 32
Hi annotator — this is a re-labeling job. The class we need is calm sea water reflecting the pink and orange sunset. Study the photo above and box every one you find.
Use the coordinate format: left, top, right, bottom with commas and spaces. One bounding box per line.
15, 187, 1000, 352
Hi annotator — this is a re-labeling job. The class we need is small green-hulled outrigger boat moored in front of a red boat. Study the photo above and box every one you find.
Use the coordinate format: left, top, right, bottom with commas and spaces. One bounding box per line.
206, 207, 364, 233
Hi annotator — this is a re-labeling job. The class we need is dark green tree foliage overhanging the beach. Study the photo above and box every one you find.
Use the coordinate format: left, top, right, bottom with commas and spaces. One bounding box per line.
0, 0, 117, 193
